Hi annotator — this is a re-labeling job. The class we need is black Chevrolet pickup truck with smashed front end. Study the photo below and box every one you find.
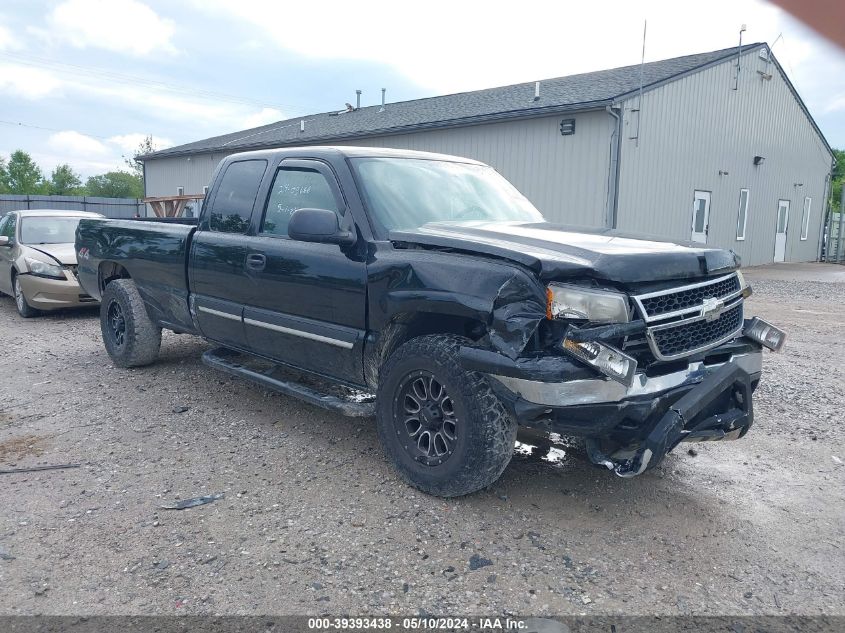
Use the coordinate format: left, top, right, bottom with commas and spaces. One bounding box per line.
76, 147, 784, 496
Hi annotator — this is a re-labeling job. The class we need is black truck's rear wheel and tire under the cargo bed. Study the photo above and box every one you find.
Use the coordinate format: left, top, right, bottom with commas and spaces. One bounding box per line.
100, 279, 161, 367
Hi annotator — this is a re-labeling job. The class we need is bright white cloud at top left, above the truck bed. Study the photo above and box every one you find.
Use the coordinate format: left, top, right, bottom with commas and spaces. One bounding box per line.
47, 0, 176, 57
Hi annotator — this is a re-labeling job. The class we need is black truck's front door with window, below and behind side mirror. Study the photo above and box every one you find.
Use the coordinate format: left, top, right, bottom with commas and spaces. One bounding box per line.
244, 159, 366, 381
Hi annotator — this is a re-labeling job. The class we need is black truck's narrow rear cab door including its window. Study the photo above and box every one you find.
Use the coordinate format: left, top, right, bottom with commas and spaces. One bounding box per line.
188, 160, 267, 349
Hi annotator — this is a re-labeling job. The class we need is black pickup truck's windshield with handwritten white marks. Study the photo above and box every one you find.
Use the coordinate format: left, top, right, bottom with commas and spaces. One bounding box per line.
351, 158, 543, 231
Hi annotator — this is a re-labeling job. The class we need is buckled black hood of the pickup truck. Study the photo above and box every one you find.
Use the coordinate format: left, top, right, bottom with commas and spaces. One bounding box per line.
390, 222, 740, 283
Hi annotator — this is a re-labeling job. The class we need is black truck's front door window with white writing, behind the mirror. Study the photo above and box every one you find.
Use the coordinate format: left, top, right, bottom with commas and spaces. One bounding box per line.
261, 167, 340, 236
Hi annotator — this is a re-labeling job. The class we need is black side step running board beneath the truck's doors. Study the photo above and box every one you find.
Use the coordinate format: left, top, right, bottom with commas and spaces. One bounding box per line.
202, 347, 375, 417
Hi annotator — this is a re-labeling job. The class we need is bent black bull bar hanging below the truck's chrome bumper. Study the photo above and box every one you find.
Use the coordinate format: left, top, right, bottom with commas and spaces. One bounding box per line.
587, 363, 754, 477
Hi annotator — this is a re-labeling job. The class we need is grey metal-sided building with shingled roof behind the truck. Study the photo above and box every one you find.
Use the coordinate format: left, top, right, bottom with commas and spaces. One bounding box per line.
142, 43, 833, 265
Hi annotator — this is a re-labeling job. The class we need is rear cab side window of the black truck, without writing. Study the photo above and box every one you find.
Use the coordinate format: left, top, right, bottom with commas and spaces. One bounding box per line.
208, 160, 267, 233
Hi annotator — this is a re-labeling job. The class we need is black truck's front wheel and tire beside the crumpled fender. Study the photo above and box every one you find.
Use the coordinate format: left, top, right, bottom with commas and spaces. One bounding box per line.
376, 334, 517, 497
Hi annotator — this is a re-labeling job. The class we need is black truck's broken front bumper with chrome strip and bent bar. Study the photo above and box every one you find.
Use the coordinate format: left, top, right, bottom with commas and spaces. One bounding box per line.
461, 338, 762, 477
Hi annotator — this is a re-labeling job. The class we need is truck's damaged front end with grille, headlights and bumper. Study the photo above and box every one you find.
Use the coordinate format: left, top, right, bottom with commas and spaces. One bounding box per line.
461, 272, 785, 477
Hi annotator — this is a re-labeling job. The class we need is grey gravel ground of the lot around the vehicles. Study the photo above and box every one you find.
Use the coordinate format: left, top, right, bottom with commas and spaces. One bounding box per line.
0, 270, 845, 615
